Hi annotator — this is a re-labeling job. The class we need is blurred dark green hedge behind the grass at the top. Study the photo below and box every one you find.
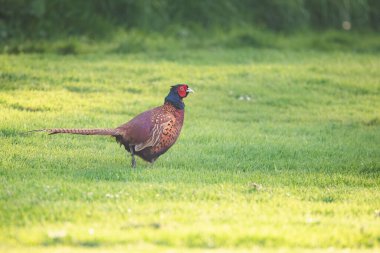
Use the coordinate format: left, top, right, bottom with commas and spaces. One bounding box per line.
0, 0, 380, 45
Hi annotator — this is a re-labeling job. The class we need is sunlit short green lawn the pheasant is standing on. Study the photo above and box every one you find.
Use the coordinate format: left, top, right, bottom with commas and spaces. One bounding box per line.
0, 48, 380, 252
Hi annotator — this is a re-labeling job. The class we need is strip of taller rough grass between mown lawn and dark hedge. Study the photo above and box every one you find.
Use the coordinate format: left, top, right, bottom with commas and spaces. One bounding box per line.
0, 27, 380, 55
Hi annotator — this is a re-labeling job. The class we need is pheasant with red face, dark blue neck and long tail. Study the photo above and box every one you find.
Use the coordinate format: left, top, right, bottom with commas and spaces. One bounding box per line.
35, 84, 194, 168
